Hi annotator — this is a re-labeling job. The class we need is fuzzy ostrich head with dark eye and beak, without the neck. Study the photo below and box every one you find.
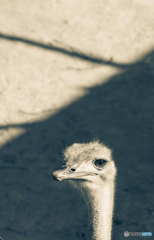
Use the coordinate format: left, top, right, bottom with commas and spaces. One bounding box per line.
53, 141, 116, 188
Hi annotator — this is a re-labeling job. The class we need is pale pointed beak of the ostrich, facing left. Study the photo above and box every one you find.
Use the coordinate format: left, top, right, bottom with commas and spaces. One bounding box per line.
53, 167, 97, 181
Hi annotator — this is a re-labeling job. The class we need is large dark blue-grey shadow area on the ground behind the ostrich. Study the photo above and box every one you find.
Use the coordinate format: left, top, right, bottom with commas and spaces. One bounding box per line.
0, 47, 154, 240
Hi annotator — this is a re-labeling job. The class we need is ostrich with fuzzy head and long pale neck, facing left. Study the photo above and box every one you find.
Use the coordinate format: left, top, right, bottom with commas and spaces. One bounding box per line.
53, 140, 116, 240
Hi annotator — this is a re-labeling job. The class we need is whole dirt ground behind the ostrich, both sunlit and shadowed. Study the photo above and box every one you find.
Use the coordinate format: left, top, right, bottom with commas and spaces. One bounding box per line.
0, 0, 154, 240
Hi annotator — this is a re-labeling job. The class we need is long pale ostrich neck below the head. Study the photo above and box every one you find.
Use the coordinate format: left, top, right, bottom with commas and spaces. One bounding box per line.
85, 182, 114, 240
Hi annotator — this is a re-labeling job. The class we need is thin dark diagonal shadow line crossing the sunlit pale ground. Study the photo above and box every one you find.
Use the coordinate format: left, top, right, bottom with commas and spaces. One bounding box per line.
0, 33, 135, 69
